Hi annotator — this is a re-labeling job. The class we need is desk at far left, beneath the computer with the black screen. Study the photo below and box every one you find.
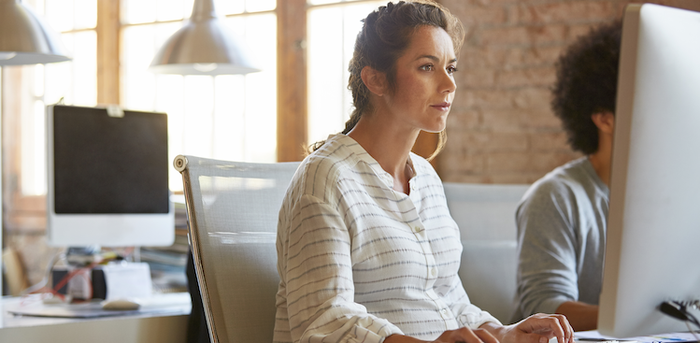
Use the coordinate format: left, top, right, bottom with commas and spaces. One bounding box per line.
0, 293, 191, 343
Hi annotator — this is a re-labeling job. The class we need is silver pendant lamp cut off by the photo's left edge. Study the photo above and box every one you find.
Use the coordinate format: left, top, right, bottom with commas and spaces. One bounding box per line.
0, 0, 71, 66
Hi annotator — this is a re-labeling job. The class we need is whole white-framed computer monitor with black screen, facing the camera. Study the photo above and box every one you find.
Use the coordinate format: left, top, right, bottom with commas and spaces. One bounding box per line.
46, 105, 175, 247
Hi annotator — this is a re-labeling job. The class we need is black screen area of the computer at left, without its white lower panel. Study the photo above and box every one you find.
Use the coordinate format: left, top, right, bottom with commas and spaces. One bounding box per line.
52, 105, 170, 214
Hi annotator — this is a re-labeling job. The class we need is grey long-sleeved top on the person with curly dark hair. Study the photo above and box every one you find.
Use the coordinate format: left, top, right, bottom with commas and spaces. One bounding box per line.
513, 157, 610, 320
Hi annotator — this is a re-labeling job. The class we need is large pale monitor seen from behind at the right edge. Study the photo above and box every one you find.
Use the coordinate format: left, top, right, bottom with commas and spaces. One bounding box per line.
598, 4, 700, 337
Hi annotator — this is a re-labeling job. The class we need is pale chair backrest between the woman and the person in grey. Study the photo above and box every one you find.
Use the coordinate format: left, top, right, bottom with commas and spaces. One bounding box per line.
444, 182, 529, 324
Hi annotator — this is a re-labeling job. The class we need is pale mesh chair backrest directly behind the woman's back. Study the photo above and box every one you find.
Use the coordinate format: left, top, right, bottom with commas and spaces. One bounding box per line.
174, 155, 299, 343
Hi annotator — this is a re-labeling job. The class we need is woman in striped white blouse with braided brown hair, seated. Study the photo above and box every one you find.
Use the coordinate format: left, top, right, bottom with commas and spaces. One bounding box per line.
274, 2, 573, 343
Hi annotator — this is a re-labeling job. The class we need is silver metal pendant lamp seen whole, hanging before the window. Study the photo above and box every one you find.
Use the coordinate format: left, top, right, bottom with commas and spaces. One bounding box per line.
149, 0, 260, 75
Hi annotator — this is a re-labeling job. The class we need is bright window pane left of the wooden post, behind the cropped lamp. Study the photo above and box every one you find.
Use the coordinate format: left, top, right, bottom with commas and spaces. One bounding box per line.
19, 0, 97, 196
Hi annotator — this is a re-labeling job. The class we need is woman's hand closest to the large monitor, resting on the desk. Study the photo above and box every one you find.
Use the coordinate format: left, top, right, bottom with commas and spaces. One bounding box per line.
481, 313, 574, 343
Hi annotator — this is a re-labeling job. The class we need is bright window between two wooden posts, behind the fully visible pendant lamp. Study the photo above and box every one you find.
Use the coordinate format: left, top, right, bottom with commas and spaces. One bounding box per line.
120, 0, 277, 191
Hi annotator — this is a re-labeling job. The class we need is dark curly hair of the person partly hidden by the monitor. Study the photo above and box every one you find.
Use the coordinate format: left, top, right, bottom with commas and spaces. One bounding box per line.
551, 20, 622, 155
